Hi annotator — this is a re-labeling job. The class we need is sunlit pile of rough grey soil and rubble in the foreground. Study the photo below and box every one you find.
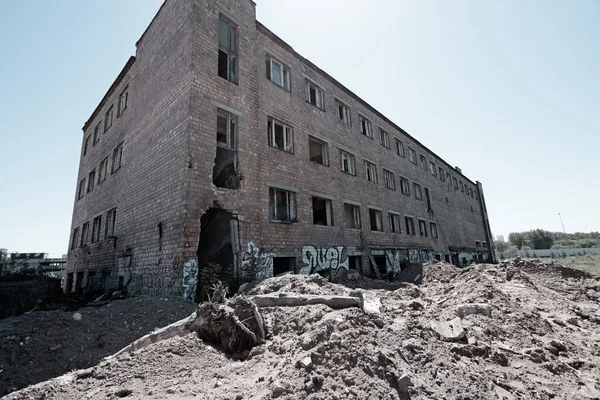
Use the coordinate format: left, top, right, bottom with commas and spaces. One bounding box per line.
7, 260, 600, 400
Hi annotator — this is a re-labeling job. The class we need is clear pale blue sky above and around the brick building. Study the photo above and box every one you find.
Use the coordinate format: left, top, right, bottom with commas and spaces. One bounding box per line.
0, 0, 600, 256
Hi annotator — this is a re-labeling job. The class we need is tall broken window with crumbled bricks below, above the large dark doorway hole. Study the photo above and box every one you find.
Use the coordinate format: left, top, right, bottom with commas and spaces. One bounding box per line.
213, 109, 239, 189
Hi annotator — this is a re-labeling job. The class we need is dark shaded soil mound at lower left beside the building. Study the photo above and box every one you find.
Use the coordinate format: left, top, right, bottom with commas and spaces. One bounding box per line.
0, 297, 196, 396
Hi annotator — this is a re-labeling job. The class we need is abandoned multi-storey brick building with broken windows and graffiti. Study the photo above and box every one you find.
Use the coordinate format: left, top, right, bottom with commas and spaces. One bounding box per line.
64, 0, 493, 298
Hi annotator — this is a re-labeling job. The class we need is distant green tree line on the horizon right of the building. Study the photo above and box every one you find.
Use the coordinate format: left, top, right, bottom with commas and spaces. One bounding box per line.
496, 229, 600, 252
